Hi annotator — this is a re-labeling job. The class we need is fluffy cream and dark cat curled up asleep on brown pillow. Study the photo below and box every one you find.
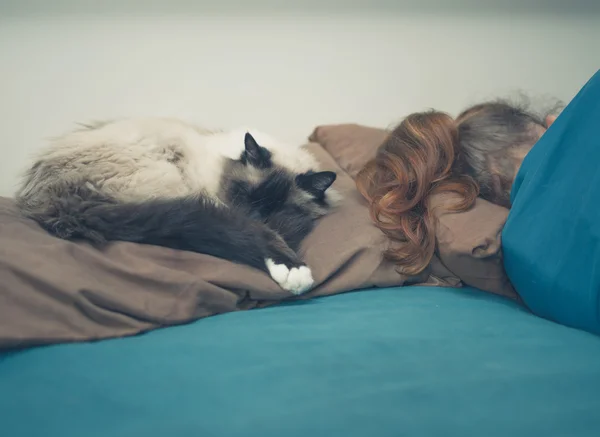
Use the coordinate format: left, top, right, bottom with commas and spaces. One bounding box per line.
16, 118, 339, 295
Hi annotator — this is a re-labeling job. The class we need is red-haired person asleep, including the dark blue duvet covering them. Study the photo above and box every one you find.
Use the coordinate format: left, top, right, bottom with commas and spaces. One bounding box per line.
357, 71, 600, 335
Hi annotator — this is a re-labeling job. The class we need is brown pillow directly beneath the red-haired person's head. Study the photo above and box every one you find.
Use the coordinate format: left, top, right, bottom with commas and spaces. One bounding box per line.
310, 124, 518, 299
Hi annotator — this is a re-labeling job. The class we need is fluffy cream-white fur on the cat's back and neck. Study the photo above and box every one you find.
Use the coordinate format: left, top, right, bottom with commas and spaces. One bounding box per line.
19, 118, 317, 202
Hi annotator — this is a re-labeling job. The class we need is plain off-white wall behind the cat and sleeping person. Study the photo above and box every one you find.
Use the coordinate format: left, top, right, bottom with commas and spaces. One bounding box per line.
0, 0, 600, 195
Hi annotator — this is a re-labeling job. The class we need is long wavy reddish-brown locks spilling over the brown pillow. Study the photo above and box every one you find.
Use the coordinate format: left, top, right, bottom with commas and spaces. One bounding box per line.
357, 112, 479, 275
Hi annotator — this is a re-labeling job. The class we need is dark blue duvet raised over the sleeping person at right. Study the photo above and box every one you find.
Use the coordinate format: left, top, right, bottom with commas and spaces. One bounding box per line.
502, 71, 600, 334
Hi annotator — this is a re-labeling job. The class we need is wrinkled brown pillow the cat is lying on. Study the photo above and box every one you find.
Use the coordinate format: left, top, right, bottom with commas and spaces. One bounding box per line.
0, 144, 414, 349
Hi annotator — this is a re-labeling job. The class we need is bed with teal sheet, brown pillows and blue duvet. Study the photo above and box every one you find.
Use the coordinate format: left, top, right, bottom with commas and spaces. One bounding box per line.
0, 74, 600, 437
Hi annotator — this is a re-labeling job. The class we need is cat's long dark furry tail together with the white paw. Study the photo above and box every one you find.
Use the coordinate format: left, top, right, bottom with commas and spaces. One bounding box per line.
17, 185, 313, 294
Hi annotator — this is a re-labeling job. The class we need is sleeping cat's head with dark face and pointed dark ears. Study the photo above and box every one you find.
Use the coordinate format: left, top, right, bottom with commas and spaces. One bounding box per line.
221, 133, 339, 219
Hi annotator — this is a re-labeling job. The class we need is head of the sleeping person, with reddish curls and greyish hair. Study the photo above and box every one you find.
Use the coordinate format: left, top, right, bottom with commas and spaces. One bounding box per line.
357, 101, 553, 274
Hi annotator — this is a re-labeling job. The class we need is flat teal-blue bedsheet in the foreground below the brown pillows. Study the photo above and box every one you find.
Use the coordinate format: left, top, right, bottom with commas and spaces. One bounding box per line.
0, 287, 600, 437
